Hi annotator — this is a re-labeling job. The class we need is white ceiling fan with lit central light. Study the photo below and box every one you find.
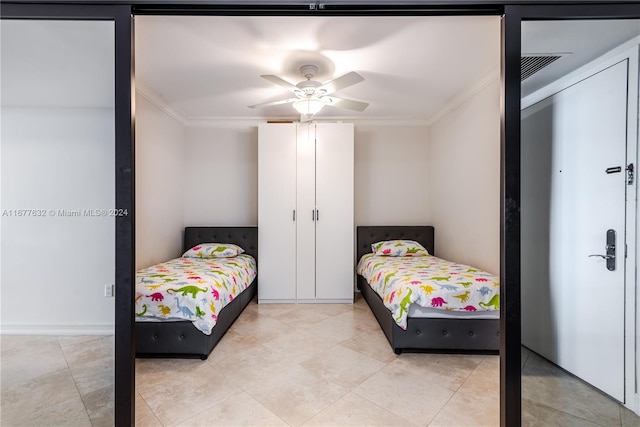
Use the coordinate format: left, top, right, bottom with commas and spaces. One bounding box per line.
249, 65, 369, 121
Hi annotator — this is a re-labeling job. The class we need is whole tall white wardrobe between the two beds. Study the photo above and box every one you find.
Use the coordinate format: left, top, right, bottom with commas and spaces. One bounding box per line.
258, 122, 355, 303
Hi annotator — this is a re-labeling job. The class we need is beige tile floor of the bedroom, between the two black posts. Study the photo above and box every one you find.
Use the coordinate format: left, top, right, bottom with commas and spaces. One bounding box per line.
136, 298, 499, 426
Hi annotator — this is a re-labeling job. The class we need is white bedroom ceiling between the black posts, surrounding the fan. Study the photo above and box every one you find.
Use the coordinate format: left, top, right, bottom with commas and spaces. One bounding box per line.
135, 16, 500, 123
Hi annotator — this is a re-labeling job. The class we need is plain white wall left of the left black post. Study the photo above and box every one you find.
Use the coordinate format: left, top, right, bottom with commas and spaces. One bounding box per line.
1, 106, 115, 333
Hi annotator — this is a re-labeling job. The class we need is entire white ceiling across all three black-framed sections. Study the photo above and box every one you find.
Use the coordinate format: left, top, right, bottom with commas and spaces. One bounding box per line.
0, 16, 640, 118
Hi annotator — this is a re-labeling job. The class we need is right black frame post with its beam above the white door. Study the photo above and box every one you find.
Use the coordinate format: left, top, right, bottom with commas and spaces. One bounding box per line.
500, 4, 640, 426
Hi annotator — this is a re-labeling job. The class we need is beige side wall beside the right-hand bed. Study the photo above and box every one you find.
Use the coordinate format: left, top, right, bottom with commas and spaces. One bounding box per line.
429, 79, 500, 275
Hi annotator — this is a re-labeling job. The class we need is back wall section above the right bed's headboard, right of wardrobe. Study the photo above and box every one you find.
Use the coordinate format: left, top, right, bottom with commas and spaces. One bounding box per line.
355, 126, 431, 225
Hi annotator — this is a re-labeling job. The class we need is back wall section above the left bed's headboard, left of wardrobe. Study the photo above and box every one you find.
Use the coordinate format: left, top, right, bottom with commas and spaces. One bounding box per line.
183, 127, 258, 226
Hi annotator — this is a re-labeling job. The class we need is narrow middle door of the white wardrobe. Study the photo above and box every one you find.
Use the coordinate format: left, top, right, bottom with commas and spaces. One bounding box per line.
296, 123, 316, 302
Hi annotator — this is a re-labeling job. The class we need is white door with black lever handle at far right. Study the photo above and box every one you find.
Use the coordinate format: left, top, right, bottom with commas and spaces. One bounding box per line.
549, 60, 627, 401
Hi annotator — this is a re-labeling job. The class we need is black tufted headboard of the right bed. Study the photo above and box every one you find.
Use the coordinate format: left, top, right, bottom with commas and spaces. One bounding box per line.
356, 225, 435, 261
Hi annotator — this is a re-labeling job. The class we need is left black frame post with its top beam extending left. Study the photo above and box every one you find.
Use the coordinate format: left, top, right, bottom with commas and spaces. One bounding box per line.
0, 3, 135, 426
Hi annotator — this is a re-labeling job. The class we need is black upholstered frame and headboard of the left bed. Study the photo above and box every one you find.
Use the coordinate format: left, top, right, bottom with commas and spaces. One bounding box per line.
136, 227, 258, 360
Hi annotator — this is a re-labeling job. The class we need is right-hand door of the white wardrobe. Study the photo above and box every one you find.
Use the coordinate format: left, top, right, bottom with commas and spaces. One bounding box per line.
316, 123, 355, 302
